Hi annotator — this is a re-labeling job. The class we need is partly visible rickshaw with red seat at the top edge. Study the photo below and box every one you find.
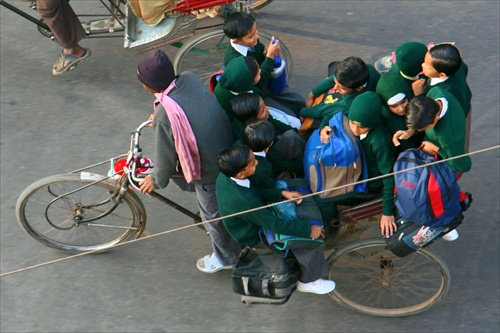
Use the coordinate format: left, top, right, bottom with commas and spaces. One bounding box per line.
0, 0, 293, 80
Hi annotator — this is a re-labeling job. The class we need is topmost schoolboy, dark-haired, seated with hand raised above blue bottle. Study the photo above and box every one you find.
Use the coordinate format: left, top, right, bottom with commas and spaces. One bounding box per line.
223, 12, 305, 116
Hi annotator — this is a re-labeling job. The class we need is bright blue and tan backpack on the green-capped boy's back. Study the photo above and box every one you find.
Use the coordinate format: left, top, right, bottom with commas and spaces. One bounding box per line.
304, 112, 368, 199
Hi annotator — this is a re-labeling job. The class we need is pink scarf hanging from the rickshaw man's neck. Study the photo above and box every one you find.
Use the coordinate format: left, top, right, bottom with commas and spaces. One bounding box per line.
154, 80, 201, 183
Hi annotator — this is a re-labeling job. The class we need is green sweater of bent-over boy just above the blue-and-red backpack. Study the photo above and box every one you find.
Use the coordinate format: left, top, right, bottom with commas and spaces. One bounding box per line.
424, 87, 472, 172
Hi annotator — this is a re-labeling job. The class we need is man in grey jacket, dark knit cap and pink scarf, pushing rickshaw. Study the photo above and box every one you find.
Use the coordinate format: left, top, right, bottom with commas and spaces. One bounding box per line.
137, 50, 241, 273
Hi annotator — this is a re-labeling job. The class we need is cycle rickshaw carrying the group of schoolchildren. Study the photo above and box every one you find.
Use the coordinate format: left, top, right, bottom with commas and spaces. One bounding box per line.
16, 120, 450, 317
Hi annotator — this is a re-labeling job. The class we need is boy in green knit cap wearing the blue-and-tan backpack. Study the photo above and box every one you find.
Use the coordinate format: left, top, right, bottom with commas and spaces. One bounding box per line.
321, 91, 396, 236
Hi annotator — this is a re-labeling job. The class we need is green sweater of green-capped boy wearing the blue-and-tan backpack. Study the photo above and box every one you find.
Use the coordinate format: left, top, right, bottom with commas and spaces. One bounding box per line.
361, 124, 396, 216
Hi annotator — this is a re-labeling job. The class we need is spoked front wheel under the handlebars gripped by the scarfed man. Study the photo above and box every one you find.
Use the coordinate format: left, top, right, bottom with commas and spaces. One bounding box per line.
16, 172, 146, 252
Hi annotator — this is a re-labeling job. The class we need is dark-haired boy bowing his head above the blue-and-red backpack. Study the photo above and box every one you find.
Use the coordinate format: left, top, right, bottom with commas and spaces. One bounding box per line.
395, 87, 472, 173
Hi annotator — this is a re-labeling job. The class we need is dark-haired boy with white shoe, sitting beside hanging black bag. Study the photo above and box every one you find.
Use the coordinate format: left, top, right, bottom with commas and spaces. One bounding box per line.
216, 145, 335, 294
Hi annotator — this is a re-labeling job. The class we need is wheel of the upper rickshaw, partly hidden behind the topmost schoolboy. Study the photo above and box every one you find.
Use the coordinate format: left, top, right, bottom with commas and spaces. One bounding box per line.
174, 30, 293, 82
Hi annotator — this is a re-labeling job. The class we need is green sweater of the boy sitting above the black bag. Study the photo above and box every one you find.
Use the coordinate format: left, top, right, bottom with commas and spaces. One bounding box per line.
215, 173, 311, 246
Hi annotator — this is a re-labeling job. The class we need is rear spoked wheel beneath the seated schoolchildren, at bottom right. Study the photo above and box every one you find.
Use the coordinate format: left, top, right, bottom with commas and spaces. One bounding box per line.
327, 239, 450, 317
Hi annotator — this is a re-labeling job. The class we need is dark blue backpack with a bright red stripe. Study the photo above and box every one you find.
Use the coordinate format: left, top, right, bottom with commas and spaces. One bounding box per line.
394, 148, 461, 227
